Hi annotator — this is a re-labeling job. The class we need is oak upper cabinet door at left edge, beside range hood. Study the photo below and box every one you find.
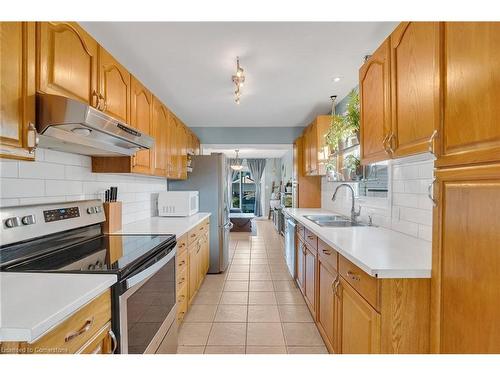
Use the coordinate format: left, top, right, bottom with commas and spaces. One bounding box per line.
0, 22, 35, 160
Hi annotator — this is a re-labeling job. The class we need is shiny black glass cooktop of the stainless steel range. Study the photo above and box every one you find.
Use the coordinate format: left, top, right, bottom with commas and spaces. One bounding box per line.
0, 226, 175, 277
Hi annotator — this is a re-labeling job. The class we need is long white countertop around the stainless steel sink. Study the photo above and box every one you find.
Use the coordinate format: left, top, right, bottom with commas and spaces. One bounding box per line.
285, 208, 432, 278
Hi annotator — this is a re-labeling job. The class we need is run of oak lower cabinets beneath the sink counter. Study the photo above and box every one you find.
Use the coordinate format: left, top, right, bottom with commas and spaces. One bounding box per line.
296, 229, 432, 354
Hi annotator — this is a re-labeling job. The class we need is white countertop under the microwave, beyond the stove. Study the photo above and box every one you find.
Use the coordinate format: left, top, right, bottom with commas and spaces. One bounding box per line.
116, 212, 211, 238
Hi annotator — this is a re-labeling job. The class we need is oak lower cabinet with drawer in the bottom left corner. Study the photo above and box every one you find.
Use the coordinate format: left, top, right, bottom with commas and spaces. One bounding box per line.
0, 290, 116, 354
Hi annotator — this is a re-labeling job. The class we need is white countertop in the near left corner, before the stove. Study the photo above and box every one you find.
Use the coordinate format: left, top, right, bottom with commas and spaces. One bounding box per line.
0, 272, 116, 343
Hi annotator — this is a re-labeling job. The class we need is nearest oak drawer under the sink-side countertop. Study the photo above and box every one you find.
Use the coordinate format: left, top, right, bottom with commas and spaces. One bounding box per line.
339, 255, 378, 310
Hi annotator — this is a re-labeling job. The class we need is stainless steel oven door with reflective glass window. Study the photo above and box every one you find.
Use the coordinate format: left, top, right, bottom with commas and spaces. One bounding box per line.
119, 249, 177, 354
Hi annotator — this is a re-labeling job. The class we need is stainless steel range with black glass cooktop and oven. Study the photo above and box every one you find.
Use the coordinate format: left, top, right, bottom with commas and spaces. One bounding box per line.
0, 200, 177, 353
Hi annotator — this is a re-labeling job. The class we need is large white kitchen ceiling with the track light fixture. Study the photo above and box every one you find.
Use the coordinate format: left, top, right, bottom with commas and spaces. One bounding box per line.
81, 22, 396, 127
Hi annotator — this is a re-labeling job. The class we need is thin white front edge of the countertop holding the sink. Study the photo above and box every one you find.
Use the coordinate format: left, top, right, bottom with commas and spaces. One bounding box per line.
285, 209, 431, 279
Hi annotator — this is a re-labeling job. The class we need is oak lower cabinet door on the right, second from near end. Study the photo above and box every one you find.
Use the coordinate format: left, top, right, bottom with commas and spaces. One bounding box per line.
317, 257, 339, 353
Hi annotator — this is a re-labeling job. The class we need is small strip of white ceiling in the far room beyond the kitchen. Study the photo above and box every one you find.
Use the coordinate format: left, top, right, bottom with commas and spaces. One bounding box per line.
203, 144, 293, 159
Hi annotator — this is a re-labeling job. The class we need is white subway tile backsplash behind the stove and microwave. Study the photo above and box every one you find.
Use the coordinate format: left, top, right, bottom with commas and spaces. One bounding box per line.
0, 149, 167, 224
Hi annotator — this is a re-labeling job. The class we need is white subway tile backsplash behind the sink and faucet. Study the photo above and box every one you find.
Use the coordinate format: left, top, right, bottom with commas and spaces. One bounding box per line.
321, 155, 434, 241
